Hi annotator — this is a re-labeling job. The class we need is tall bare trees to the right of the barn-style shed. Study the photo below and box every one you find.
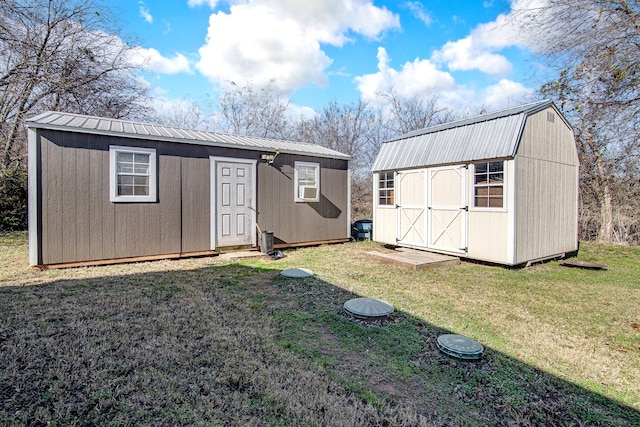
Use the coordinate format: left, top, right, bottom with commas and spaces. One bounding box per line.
529, 0, 640, 244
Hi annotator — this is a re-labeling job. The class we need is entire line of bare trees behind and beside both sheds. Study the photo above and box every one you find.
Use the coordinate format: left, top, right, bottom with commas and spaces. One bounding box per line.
0, 0, 640, 245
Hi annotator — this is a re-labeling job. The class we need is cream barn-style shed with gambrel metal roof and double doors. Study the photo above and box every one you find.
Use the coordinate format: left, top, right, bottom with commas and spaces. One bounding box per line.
372, 101, 578, 265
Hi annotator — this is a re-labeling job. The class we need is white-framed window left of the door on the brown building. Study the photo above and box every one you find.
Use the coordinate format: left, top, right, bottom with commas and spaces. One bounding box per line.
109, 145, 158, 202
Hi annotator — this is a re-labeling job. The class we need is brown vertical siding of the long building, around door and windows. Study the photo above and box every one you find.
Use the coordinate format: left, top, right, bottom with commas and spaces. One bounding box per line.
38, 130, 348, 264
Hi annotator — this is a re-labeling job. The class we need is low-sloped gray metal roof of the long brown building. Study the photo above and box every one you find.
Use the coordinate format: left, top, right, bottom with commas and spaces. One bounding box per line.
27, 111, 351, 159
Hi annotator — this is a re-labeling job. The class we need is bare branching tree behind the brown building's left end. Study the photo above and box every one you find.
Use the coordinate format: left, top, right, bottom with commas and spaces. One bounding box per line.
0, 0, 147, 171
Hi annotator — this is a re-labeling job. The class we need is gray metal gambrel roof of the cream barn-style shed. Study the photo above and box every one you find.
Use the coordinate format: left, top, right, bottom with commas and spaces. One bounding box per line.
371, 100, 564, 172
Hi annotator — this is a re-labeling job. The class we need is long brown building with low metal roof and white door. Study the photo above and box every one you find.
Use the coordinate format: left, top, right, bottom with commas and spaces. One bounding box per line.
27, 112, 351, 265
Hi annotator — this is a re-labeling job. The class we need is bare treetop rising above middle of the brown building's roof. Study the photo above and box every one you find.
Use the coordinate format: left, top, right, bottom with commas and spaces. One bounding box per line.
216, 81, 291, 139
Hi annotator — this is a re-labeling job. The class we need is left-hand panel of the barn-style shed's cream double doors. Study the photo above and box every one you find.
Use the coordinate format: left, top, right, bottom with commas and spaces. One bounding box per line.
396, 170, 427, 247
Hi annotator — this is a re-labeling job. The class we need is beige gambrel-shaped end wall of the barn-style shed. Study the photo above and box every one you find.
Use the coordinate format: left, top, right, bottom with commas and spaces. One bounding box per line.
514, 108, 578, 264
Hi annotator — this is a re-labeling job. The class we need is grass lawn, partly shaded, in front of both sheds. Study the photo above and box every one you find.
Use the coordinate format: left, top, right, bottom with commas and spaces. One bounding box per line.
0, 234, 640, 426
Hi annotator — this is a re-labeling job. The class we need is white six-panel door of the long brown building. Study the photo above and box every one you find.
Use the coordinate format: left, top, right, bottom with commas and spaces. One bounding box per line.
211, 158, 256, 247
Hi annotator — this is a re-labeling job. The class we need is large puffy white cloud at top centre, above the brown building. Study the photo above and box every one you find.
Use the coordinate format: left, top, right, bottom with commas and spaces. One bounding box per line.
192, 0, 400, 92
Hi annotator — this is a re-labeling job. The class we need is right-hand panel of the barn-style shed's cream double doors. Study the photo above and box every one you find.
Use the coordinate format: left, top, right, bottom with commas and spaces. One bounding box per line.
427, 166, 469, 254
